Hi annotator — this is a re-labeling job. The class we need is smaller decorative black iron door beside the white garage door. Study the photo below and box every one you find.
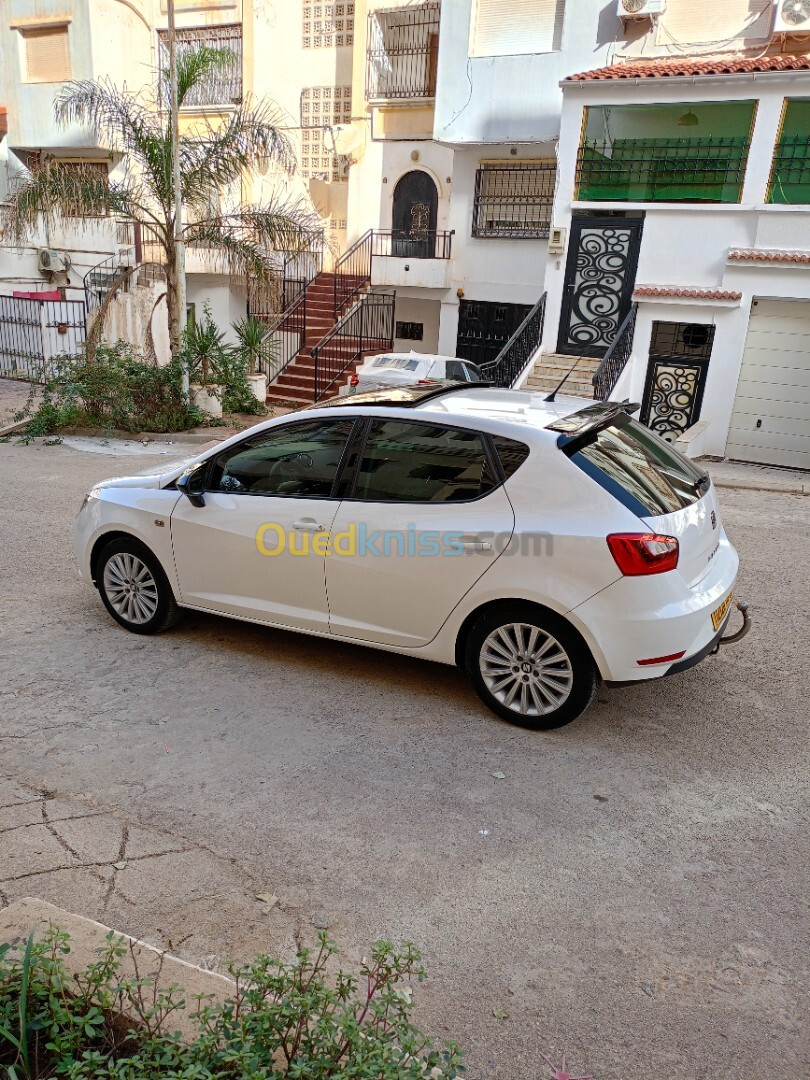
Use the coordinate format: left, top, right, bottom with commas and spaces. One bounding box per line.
639, 322, 715, 443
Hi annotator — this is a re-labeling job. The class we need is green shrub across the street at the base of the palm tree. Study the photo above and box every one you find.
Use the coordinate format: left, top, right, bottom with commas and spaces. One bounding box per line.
18, 341, 205, 435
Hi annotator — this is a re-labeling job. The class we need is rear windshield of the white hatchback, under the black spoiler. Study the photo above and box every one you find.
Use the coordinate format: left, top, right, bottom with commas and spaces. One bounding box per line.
561, 417, 708, 517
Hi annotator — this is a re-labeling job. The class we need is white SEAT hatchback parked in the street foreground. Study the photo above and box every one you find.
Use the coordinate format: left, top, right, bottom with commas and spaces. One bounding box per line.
75, 384, 748, 728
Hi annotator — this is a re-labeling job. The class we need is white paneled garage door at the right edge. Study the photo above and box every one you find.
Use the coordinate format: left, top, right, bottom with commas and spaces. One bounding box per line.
726, 300, 810, 469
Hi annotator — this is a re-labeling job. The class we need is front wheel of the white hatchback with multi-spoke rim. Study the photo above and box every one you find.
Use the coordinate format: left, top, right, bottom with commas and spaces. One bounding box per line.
96, 537, 181, 634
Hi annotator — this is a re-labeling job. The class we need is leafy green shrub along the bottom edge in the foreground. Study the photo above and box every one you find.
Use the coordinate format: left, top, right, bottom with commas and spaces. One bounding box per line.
0, 928, 463, 1080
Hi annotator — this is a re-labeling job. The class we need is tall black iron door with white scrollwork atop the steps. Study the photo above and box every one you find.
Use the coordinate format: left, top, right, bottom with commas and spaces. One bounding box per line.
557, 217, 644, 357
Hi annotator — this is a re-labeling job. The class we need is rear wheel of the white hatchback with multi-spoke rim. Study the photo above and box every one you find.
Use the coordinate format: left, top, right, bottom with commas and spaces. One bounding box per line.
464, 604, 596, 731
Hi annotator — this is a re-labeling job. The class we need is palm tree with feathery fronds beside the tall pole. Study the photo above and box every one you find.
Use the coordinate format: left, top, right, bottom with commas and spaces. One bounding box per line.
3, 46, 322, 354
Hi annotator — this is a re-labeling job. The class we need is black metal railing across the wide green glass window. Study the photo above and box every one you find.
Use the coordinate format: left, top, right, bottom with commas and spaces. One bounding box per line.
577, 136, 748, 202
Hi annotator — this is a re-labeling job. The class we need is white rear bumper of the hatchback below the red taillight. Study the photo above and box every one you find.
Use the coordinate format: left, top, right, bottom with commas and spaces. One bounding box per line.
569, 536, 739, 683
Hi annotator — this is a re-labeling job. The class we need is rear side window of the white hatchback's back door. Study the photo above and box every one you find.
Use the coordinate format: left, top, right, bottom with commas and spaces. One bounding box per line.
354, 420, 498, 502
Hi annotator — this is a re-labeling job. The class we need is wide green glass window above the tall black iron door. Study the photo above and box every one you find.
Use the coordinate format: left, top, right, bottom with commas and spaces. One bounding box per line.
577, 102, 756, 203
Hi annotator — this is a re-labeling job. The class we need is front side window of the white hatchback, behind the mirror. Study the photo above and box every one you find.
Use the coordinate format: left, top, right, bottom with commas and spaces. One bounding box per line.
207, 419, 354, 498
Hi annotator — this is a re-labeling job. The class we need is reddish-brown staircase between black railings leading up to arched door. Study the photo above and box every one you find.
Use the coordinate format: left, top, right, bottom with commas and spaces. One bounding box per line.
267, 273, 369, 406
